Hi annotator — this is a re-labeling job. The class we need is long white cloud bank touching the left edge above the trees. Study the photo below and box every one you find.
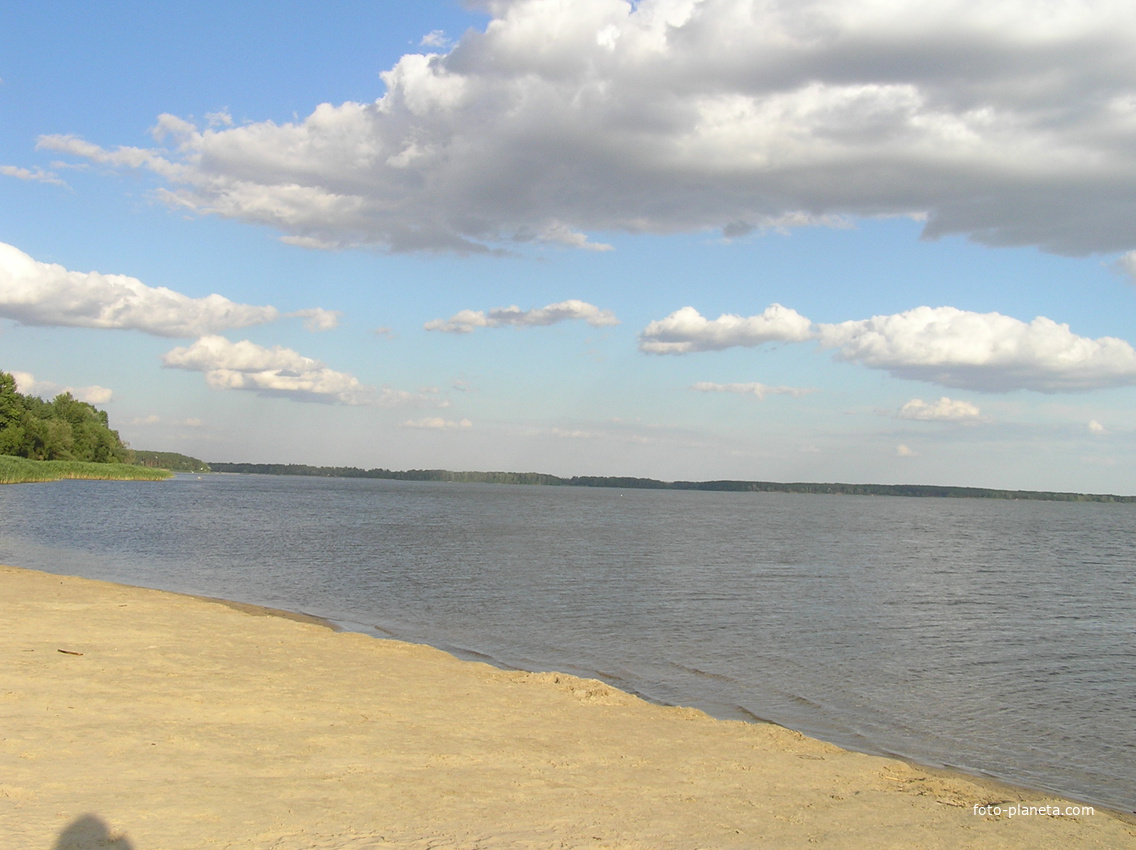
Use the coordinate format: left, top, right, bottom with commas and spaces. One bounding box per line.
0, 242, 339, 338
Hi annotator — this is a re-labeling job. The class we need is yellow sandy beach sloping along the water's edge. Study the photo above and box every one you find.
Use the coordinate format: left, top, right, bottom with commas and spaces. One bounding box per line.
0, 567, 1136, 850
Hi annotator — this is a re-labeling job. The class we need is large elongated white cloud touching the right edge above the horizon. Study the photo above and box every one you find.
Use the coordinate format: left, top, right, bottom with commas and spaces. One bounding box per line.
820, 307, 1136, 392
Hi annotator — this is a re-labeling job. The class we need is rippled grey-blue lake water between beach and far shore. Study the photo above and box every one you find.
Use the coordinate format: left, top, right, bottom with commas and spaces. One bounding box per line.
0, 475, 1136, 810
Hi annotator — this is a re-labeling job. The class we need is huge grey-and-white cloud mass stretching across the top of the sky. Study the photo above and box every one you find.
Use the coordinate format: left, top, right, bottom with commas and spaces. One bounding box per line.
39, 0, 1136, 253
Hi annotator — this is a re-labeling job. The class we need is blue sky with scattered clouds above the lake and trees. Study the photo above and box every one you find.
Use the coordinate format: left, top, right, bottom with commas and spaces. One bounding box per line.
0, 0, 1136, 494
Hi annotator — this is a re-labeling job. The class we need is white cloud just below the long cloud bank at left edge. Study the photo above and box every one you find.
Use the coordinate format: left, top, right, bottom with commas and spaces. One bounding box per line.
161, 336, 382, 405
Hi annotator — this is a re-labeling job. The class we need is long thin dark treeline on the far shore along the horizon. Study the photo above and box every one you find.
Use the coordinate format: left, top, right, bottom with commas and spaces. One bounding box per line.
208, 463, 1136, 502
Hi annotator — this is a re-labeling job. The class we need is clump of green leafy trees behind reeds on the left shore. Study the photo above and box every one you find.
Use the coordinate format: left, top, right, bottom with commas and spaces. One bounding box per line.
0, 372, 132, 464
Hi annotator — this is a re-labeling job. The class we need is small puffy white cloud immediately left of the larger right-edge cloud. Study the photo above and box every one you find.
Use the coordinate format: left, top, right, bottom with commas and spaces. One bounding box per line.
640, 303, 813, 355
